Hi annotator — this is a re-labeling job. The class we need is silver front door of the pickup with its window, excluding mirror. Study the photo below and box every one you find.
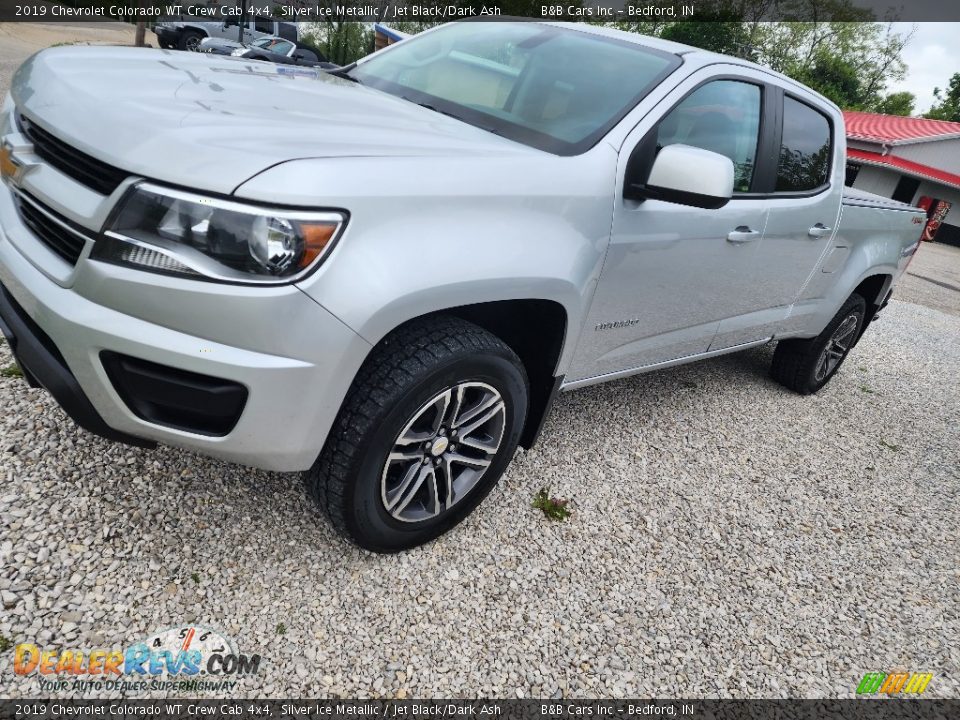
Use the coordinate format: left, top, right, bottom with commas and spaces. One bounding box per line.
568, 70, 770, 381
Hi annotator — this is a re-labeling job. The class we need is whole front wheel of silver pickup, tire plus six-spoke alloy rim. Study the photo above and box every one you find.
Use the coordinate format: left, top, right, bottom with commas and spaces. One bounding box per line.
305, 317, 528, 552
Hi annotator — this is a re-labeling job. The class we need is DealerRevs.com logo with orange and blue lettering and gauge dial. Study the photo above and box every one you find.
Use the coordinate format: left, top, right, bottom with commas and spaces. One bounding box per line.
13, 625, 262, 692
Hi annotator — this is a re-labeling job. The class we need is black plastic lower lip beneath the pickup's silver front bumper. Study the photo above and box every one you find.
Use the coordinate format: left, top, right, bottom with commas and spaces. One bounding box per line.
0, 285, 157, 448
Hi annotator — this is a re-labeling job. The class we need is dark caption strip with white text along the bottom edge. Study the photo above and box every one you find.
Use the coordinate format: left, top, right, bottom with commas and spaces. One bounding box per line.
0, 699, 960, 720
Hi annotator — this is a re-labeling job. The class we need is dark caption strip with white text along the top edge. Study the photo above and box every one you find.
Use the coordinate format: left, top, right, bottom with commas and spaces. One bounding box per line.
0, 0, 960, 23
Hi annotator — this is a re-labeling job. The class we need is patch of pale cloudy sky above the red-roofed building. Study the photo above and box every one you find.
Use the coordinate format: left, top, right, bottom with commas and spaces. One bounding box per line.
889, 22, 960, 115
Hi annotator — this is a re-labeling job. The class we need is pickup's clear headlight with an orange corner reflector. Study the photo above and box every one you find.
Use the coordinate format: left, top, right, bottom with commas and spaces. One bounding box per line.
91, 183, 346, 284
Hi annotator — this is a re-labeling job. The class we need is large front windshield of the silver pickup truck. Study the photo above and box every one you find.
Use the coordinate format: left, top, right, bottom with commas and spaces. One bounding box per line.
350, 22, 680, 155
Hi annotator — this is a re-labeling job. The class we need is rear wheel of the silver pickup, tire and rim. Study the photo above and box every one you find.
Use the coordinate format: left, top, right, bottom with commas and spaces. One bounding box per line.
770, 294, 867, 395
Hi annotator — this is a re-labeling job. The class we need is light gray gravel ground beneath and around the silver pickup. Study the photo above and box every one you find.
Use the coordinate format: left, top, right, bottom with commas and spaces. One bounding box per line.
0, 294, 960, 698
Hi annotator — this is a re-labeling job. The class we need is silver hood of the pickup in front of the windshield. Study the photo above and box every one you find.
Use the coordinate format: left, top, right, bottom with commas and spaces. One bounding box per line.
11, 47, 539, 193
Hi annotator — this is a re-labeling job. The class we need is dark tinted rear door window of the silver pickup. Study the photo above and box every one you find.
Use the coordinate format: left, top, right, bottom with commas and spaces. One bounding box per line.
776, 96, 832, 192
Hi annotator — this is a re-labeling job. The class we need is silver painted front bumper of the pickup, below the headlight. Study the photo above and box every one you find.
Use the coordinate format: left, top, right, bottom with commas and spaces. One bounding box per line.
0, 184, 370, 471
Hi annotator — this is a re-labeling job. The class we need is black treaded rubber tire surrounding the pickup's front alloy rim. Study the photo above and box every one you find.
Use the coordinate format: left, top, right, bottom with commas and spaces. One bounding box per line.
304, 316, 529, 553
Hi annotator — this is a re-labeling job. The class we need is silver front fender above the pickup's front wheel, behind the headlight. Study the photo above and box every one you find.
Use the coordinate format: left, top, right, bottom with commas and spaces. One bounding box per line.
238, 153, 613, 373
